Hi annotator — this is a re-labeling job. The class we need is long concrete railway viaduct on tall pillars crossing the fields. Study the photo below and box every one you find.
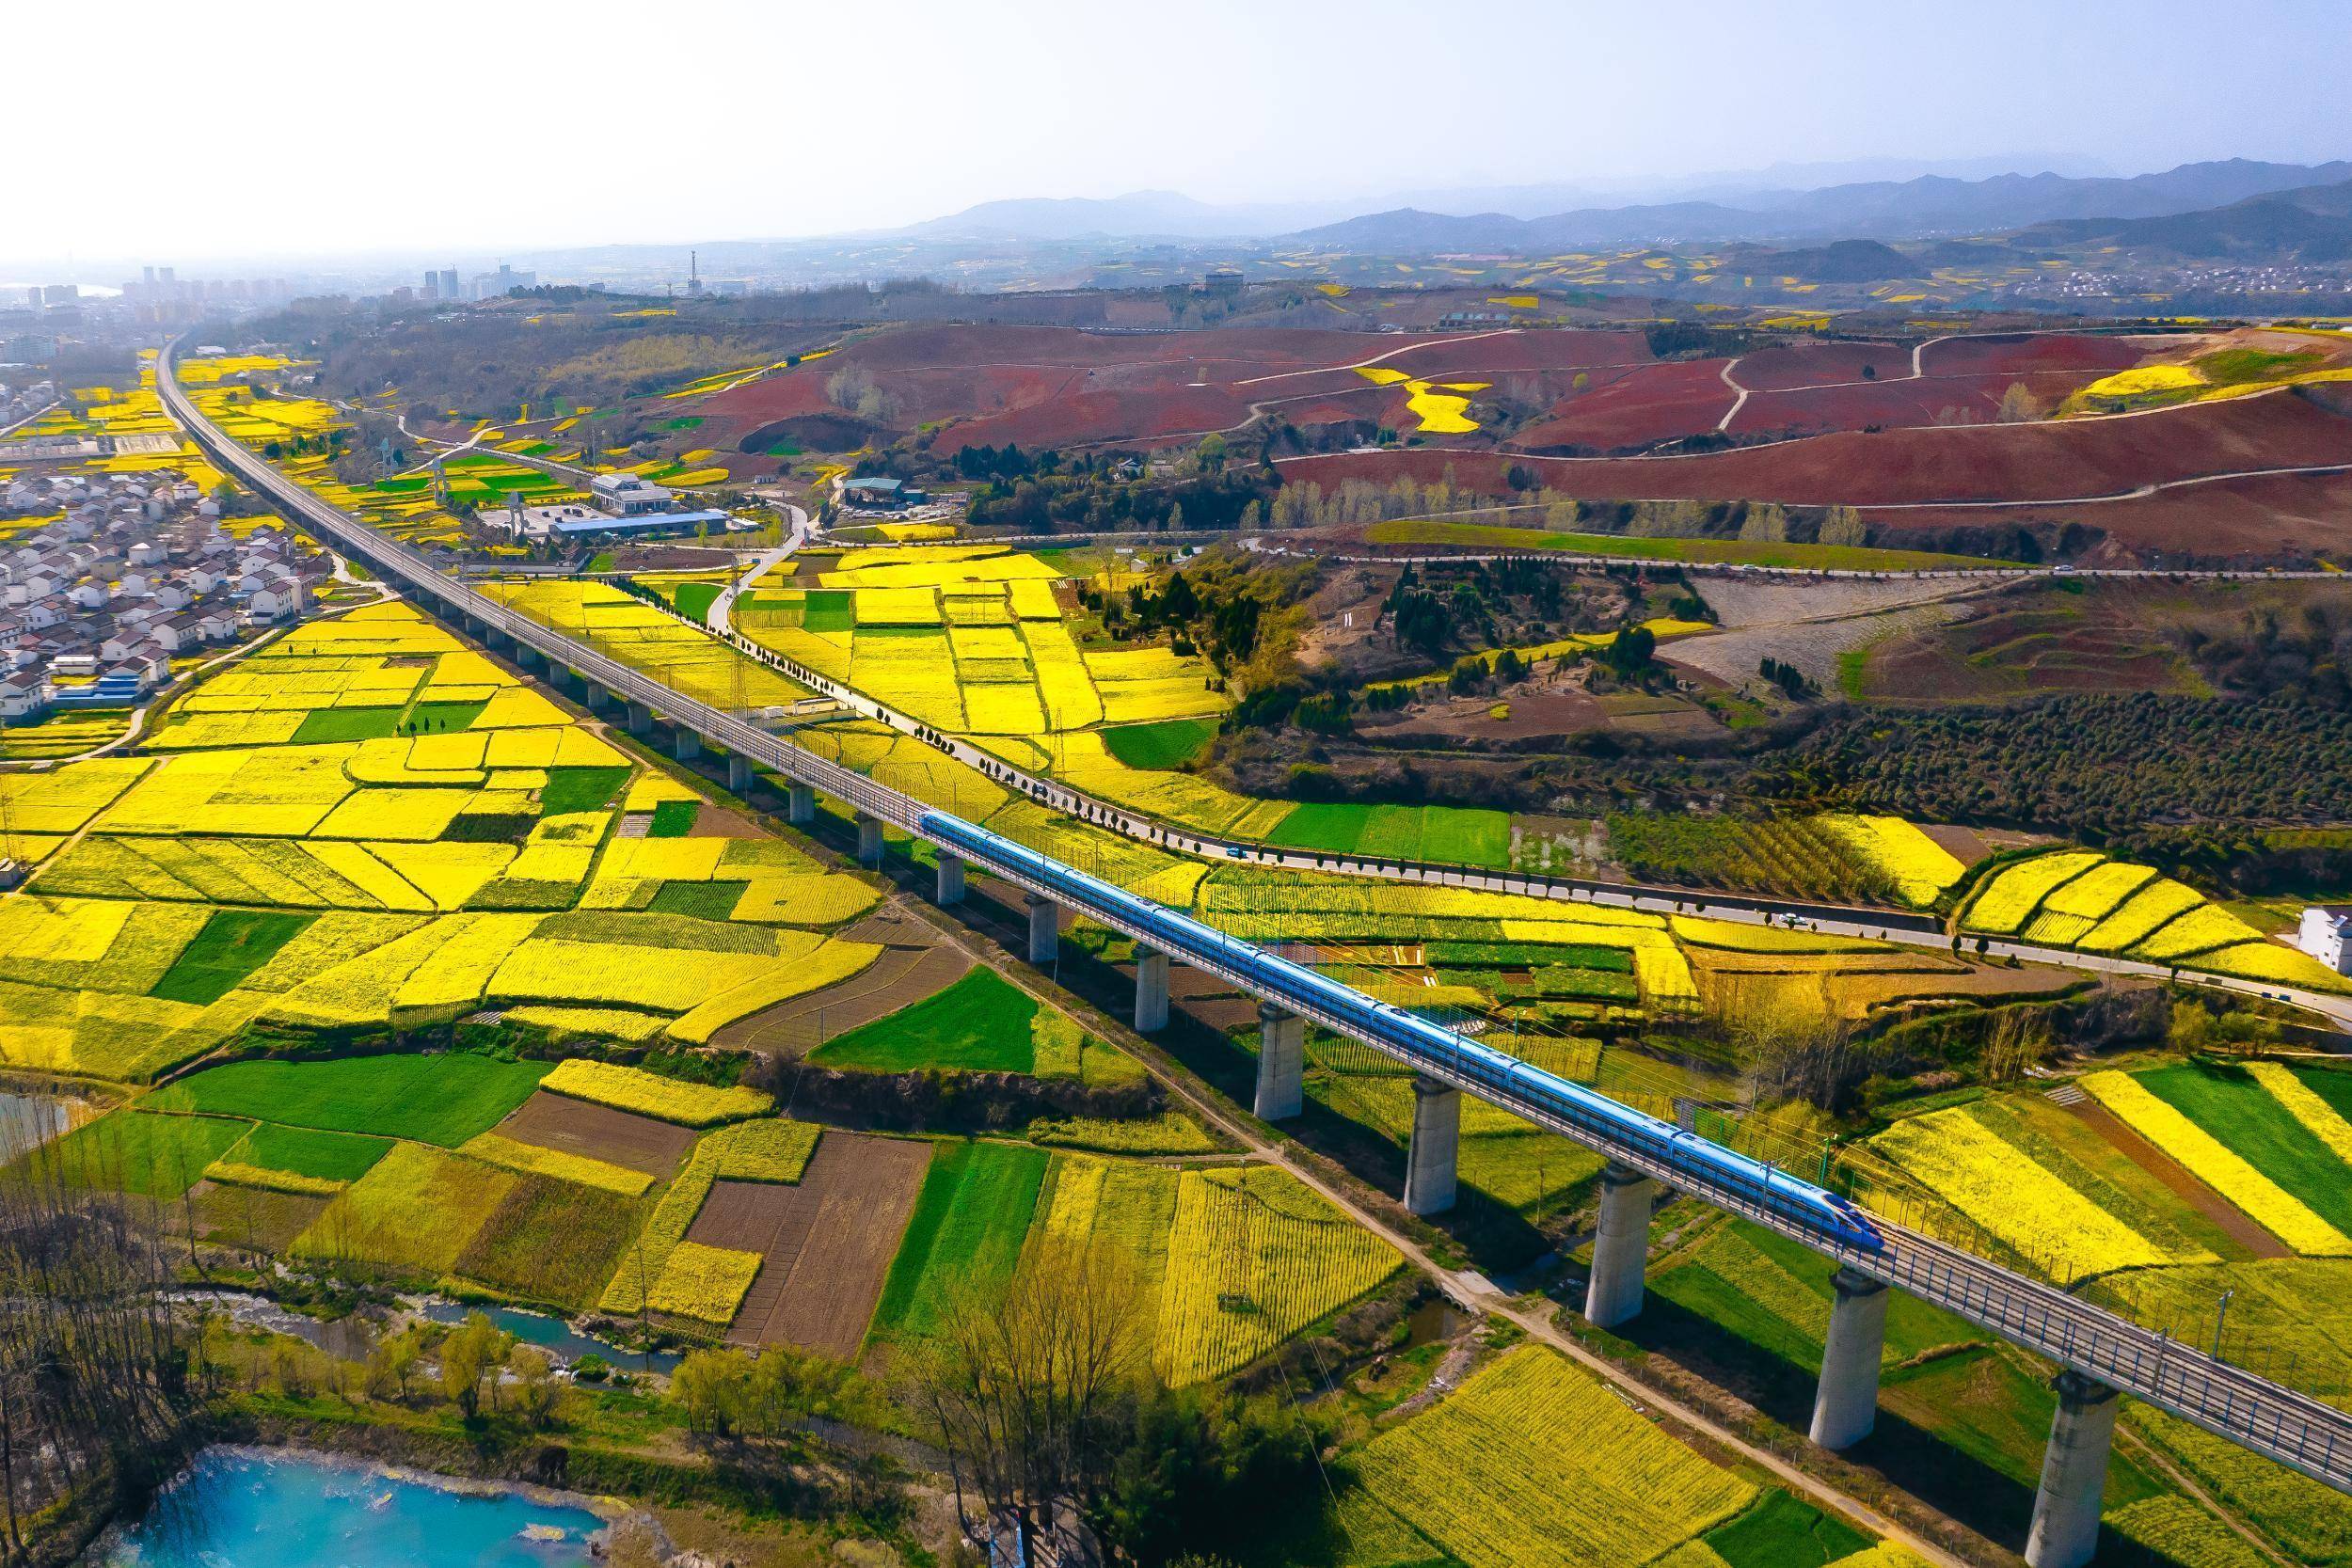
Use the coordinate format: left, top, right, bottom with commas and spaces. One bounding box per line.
158, 343, 2352, 1568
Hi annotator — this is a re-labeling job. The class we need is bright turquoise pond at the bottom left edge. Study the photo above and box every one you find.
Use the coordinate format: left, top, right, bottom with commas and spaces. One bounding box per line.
85, 1449, 602, 1568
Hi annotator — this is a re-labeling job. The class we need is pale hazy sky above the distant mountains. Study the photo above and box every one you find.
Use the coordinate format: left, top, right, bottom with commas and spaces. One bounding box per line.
18, 0, 2352, 279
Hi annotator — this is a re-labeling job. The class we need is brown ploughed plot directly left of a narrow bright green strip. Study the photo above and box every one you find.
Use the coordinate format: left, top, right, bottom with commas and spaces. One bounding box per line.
687, 1131, 931, 1361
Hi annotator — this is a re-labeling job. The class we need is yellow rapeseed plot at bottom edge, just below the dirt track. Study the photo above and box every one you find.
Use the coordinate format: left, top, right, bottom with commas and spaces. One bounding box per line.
1358, 1347, 1757, 1568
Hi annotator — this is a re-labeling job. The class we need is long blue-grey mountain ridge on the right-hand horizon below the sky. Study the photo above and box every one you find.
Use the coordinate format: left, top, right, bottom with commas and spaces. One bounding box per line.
1292, 157, 2352, 254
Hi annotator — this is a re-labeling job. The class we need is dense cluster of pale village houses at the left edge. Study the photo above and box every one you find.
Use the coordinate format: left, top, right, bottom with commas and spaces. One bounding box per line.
0, 472, 334, 724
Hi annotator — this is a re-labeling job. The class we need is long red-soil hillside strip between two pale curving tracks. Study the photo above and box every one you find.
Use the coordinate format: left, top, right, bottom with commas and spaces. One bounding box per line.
1282, 392, 2352, 510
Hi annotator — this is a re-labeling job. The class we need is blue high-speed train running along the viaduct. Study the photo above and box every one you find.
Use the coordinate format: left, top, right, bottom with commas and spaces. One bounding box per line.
922, 811, 1884, 1251
